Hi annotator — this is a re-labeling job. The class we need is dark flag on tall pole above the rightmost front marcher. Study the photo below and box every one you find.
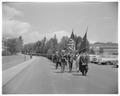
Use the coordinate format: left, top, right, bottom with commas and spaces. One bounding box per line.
79, 27, 89, 52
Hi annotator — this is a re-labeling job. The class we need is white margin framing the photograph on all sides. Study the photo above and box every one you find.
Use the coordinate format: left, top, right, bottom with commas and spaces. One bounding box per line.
0, 0, 120, 96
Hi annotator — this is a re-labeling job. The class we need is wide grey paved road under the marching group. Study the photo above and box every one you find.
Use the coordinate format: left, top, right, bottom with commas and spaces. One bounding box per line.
3, 57, 118, 94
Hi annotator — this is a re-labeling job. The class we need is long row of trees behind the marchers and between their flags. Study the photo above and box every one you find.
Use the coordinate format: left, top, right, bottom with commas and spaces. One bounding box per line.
23, 35, 89, 55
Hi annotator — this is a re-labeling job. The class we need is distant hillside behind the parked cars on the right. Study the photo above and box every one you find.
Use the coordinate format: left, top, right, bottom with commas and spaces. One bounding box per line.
90, 42, 118, 55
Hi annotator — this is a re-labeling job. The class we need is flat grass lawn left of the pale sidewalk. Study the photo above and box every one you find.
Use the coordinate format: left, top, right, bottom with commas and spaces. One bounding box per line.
2, 55, 30, 71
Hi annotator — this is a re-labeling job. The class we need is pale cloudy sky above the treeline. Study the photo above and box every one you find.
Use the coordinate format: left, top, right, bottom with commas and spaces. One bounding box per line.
2, 2, 118, 44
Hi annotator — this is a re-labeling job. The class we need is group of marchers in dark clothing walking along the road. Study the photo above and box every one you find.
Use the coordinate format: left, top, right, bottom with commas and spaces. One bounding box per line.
53, 50, 89, 76
